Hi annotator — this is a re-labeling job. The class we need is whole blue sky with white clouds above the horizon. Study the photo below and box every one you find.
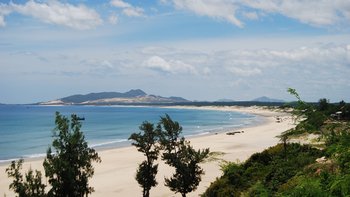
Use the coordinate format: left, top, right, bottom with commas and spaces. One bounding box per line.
0, 0, 350, 103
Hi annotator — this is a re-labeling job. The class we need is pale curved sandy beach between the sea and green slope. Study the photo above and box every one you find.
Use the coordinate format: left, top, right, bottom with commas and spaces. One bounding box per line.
0, 106, 295, 197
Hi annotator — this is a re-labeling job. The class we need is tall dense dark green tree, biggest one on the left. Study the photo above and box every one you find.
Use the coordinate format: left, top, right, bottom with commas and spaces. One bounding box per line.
43, 112, 101, 197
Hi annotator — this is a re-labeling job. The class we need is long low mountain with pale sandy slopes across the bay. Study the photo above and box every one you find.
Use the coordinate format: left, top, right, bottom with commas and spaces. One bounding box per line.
39, 89, 190, 105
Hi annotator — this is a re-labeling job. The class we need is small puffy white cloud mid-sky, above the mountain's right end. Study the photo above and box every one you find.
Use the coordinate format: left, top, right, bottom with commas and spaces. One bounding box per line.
144, 56, 197, 74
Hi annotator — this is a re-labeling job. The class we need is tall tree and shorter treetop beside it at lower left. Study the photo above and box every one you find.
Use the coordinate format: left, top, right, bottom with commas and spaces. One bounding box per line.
6, 112, 101, 197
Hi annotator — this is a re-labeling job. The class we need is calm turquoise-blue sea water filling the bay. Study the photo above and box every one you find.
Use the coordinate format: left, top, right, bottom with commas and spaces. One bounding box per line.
0, 105, 262, 162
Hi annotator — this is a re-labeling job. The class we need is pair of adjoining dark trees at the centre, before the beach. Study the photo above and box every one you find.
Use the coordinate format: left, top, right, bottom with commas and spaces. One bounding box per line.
129, 115, 209, 196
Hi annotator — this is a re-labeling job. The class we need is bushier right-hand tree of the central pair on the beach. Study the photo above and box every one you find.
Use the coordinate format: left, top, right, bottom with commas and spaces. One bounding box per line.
157, 115, 209, 197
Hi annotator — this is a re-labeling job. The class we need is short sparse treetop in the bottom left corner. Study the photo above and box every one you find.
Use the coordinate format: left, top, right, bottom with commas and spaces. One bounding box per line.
6, 159, 46, 197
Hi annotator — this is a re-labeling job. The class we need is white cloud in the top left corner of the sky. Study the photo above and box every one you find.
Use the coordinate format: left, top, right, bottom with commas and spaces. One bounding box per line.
0, 0, 102, 29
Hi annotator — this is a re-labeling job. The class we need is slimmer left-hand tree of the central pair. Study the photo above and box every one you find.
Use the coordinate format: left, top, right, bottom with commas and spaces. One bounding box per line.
129, 122, 159, 197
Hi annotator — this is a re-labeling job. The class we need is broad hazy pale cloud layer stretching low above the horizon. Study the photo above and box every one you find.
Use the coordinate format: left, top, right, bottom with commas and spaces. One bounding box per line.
4, 39, 350, 102
